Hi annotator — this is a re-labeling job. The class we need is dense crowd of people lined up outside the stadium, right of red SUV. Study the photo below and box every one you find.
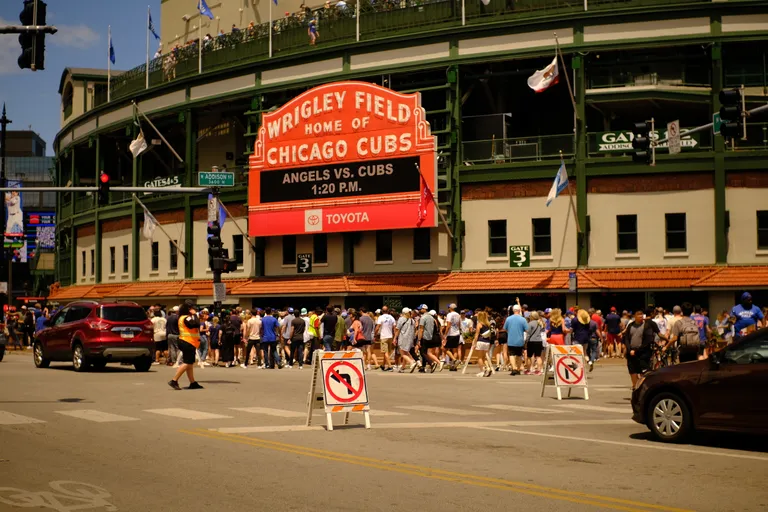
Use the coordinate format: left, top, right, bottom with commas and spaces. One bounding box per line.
141, 293, 768, 387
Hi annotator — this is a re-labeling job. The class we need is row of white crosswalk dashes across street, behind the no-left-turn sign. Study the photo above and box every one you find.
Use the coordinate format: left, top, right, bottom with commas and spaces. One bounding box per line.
0, 402, 631, 427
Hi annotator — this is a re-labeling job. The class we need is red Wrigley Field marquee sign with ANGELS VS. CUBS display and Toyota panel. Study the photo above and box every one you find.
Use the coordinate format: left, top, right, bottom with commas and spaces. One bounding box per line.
248, 81, 437, 236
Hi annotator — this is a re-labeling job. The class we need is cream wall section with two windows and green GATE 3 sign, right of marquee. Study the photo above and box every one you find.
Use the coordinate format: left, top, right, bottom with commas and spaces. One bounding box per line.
461, 197, 576, 270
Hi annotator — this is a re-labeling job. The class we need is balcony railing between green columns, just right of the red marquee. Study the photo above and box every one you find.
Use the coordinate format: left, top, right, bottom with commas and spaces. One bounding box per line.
462, 134, 574, 165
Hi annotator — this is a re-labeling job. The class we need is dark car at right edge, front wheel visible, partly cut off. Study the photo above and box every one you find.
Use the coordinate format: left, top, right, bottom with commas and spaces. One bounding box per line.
632, 329, 768, 442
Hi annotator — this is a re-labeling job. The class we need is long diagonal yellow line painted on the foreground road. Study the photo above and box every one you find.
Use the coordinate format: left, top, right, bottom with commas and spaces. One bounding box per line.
181, 430, 691, 512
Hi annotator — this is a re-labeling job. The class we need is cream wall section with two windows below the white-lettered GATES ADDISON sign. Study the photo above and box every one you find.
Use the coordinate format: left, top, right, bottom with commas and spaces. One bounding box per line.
588, 190, 716, 267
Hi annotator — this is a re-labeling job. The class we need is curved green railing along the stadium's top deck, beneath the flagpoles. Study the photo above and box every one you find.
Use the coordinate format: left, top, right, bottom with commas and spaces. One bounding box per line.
99, 0, 710, 106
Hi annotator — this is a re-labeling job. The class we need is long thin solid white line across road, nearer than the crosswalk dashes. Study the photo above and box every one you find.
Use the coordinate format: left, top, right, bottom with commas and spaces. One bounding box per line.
208, 419, 634, 434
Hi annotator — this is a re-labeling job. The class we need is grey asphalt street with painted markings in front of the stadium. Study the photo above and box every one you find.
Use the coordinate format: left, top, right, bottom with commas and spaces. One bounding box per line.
0, 353, 768, 512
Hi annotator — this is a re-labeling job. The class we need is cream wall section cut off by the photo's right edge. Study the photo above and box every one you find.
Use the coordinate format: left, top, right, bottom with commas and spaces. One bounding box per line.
725, 188, 768, 265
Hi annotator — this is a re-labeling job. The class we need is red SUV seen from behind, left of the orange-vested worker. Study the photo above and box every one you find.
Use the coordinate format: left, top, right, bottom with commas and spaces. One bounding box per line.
34, 301, 155, 372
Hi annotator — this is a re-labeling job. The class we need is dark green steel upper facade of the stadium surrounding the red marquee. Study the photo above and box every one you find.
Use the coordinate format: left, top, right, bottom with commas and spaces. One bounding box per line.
55, 0, 768, 286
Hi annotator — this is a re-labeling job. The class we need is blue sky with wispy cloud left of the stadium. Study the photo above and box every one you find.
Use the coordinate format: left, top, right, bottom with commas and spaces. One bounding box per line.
0, 0, 160, 156
